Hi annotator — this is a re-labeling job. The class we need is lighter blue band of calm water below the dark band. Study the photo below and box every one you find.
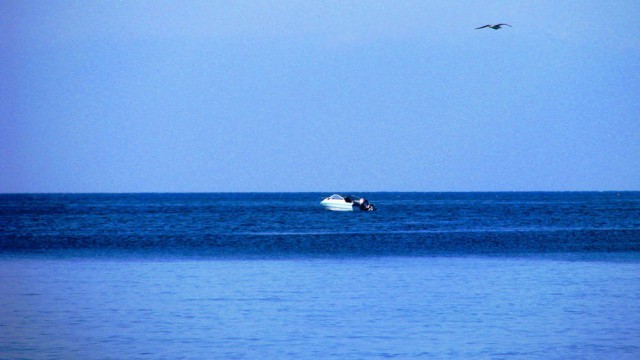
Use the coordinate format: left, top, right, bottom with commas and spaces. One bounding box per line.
0, 257, 640, 359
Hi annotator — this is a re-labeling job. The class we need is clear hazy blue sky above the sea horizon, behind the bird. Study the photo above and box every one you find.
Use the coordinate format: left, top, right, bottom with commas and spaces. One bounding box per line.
0, 0, 640, 193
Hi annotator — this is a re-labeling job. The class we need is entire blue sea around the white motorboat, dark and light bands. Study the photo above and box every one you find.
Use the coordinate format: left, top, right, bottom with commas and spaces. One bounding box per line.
0, 192, 640, 359
